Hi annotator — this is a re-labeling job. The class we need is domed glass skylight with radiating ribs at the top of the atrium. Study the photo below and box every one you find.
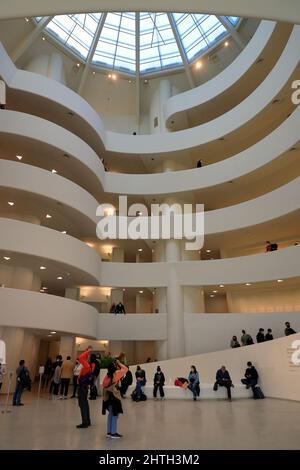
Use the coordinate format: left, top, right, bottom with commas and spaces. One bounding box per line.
36, 12, 239, 75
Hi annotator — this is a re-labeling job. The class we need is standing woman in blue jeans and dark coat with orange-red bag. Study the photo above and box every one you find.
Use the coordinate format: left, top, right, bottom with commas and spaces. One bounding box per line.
102, 359, 128, 439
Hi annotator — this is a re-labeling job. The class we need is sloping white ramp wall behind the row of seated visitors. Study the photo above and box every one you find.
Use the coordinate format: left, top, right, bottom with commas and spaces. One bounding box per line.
138, 333, 300, 401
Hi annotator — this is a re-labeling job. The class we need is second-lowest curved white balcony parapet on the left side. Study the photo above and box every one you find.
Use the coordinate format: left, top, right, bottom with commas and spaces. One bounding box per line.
0, 218, 101, 285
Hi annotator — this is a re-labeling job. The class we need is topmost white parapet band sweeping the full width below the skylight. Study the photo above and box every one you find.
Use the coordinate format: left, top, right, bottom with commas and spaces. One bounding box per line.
0, 26, 300, 156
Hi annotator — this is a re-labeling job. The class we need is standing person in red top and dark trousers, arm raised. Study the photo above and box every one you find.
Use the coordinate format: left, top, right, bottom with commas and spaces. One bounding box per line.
77, 346, 93, 429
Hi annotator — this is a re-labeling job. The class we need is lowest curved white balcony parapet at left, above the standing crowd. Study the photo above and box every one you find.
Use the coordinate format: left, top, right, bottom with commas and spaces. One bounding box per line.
0, 287, 98, 338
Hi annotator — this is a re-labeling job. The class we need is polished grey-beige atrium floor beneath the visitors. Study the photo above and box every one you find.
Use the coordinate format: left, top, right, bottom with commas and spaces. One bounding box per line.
0, 392, 300, 450
